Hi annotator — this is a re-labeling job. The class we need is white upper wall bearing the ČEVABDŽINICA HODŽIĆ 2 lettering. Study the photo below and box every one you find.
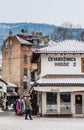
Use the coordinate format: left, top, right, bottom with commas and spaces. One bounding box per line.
40, 54, 84, 77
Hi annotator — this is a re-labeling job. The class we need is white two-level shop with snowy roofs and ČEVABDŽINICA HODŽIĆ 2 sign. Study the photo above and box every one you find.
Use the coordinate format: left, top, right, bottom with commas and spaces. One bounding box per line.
34, 40, 84, 117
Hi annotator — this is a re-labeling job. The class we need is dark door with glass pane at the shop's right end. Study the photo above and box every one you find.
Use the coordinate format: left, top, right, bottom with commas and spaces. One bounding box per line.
75, 94, 82, 114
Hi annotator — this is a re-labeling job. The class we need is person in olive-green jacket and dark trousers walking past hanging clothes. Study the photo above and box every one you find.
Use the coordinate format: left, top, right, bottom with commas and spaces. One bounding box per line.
25, 95, 32, 120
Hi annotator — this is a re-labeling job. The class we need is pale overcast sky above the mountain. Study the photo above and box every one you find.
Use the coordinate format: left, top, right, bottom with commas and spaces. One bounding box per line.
0, 0, 84, 27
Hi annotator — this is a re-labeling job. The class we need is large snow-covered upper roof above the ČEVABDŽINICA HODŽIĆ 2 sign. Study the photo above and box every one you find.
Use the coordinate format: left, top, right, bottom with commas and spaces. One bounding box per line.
35, 40, 84, 54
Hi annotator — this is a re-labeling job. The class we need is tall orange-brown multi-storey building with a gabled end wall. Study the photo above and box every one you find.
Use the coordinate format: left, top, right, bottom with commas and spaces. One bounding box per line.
2, 31, 32, 95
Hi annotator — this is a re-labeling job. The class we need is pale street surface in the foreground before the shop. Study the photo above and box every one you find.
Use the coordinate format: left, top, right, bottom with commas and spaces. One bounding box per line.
0, 113, 84, 130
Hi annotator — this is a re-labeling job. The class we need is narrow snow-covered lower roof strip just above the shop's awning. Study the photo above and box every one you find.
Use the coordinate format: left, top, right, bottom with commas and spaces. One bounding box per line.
37, 78, 84, 85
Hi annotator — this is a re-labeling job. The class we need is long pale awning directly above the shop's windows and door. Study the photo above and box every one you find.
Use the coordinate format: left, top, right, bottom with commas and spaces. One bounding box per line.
34, 87, 84, 92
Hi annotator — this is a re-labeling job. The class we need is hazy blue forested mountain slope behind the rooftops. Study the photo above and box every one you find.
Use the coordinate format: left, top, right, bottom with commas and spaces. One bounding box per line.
0, 23, 84, 49
